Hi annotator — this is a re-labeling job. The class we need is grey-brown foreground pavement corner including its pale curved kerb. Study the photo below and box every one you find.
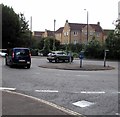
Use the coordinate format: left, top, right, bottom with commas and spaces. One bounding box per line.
2, 91, 83, 117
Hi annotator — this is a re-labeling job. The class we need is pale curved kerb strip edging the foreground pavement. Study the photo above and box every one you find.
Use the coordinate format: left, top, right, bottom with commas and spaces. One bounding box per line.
5, 91, 83, 117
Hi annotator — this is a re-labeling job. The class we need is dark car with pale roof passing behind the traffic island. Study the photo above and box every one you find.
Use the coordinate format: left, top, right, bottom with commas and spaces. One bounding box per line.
47, 51, 73, 62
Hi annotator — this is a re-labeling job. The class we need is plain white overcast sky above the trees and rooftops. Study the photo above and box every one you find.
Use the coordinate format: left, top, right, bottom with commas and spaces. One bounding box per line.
0, 0, 120, 31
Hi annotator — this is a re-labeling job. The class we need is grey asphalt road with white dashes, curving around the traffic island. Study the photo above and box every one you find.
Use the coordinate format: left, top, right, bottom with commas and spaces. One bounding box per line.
0, 57, 119, 115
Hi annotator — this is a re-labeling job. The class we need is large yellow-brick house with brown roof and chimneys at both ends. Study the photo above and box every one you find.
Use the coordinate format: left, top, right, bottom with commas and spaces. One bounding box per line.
55, 20, 104, 44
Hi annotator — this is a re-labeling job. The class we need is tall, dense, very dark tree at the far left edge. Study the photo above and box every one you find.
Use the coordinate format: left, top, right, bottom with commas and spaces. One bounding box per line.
2, 4, 20, 48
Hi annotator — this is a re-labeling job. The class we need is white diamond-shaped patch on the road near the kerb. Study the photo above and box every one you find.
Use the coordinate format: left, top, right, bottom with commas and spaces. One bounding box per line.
73, 100, 94, 108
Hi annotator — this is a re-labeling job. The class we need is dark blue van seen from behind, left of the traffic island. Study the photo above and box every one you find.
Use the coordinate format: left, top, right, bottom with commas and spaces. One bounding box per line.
6, 48, 31, 68
